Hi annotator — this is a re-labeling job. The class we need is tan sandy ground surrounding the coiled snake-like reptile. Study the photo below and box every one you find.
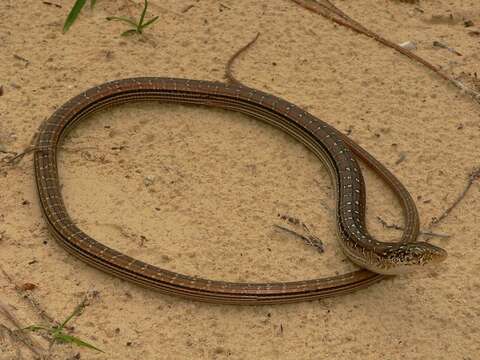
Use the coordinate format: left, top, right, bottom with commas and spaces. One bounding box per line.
0, 0, 480, 360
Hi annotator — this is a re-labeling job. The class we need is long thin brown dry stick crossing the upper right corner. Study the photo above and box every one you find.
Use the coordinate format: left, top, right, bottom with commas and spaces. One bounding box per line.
292, 0, 480, 103
